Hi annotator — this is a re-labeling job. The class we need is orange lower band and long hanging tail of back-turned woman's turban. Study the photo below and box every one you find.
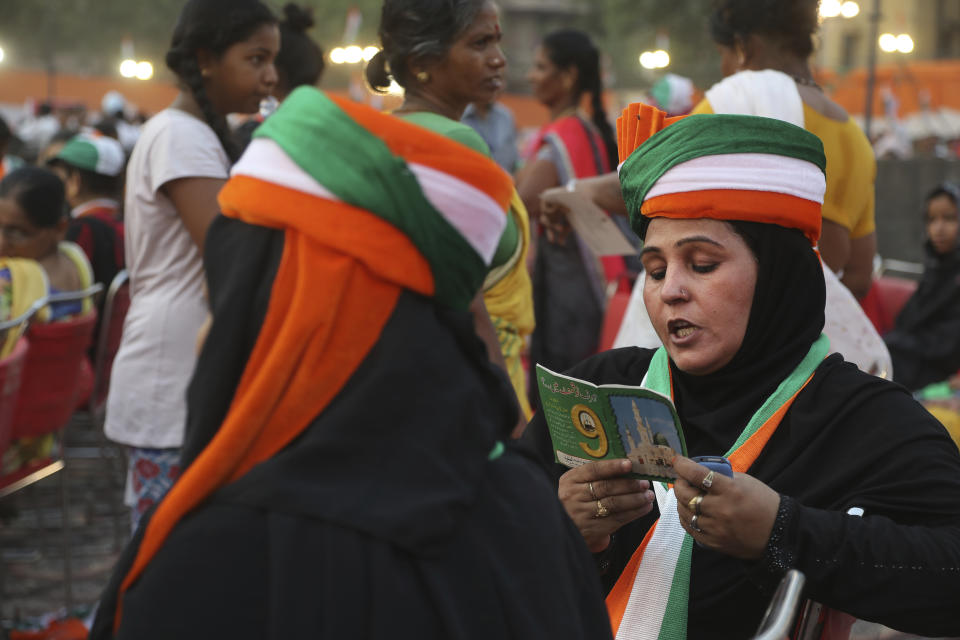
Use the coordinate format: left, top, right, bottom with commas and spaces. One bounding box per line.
114, 176, 434, 630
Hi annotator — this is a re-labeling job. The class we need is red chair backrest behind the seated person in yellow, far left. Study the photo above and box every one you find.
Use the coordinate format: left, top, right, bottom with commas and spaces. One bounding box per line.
13, 312, 97, 438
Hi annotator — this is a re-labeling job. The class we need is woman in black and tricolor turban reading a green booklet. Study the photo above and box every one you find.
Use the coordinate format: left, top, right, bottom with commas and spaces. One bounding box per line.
525, 106, 960, 639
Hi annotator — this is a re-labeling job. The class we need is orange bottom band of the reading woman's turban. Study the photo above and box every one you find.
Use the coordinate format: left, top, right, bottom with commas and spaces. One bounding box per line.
640, 189, 821, 245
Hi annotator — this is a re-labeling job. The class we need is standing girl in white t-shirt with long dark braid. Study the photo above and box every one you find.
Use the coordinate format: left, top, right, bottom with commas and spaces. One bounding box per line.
105, 0, 280, 529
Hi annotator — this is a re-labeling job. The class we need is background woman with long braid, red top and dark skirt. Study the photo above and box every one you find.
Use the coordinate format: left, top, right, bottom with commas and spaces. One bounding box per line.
517, 29, 625, 398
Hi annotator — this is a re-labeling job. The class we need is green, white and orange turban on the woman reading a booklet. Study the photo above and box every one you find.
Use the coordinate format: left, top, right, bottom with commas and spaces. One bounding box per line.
617, 105, 826, 245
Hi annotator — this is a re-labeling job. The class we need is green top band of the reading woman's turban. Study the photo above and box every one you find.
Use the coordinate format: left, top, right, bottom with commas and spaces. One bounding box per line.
620, 113, 826, 221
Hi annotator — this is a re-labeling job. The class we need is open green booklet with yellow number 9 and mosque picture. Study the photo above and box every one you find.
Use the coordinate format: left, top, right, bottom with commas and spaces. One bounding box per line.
537, 365, 687, 482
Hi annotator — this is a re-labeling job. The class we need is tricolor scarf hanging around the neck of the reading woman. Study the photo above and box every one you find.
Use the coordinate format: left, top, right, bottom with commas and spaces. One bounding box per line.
607, 335, 830, 640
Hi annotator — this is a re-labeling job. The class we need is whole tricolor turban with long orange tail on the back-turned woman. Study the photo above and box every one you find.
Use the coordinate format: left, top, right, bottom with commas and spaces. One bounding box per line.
114, 88, 513, 629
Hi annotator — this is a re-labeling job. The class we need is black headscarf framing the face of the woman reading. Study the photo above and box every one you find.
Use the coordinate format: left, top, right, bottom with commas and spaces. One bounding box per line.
670, 221, 826, 455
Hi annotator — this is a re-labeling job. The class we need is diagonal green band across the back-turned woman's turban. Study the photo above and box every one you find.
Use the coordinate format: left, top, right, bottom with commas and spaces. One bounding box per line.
254, 87, 487, 309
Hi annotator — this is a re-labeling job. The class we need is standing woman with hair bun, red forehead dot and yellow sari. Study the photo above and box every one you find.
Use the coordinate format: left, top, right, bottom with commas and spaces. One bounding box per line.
366, 0, 534, 430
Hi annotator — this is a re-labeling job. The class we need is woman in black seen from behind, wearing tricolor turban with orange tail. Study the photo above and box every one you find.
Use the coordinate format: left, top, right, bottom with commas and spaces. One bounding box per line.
92, 87, 609, 640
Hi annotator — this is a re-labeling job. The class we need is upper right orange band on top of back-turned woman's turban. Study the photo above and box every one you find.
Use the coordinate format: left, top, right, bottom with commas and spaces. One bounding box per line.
327, 94, 513, 211
